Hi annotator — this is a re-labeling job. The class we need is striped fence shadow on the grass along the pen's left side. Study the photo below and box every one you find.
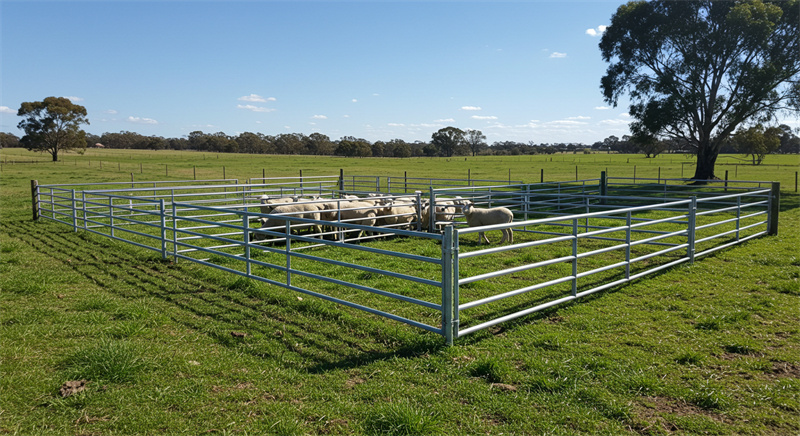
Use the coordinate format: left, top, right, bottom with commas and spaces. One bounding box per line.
4, 220, 446, 373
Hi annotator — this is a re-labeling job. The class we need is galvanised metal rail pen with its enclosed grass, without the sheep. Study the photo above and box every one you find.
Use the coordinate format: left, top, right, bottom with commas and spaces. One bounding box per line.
31, 171, 780, 344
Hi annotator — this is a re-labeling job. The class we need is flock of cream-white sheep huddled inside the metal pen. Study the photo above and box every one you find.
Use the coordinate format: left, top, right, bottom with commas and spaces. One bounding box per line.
254, 194, 514, 244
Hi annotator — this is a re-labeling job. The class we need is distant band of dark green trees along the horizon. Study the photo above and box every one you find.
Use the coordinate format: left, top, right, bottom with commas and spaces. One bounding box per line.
0, 125, 800, 163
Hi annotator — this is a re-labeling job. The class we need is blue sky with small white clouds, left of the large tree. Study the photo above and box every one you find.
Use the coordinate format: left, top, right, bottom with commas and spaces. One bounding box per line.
0, 0, 629, 144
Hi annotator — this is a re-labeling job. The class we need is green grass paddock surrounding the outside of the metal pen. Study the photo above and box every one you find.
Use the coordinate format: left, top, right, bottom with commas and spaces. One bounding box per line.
0, 149, 800, 435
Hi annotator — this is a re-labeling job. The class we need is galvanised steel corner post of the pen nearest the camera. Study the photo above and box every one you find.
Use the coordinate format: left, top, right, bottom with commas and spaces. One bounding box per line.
442, 224, 459, 345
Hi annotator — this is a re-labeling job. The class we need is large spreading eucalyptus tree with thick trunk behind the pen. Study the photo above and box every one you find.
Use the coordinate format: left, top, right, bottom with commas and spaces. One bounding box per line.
600, 0, 800, 179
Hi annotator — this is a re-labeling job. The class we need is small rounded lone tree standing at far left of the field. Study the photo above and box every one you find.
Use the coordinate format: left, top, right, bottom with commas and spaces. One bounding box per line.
17, 97, 89, 162
